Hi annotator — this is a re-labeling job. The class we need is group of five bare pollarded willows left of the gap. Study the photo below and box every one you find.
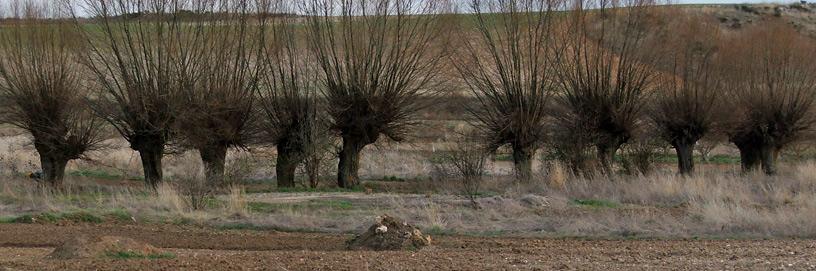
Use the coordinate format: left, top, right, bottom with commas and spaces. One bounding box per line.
0, 0, 449, 188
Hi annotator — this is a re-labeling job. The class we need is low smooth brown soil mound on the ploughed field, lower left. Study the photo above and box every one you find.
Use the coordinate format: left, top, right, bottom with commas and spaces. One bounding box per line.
48, 236, 162, 259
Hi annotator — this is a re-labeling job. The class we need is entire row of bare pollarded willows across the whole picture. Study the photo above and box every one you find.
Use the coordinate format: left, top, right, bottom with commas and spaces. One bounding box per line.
0, 0, 814, 191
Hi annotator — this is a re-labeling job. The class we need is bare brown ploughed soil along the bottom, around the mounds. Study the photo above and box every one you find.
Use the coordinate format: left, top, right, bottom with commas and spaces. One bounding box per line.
0, 224, 816, 270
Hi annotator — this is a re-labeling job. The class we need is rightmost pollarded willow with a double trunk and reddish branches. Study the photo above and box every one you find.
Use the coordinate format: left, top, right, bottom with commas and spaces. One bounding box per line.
723, 22, 816, 175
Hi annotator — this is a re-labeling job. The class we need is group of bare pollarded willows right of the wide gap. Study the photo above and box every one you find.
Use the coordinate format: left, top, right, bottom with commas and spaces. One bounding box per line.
454, 0, 816, 179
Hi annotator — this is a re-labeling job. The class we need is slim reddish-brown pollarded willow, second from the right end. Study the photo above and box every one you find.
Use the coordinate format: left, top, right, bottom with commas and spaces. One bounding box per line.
649, 15, 724, 175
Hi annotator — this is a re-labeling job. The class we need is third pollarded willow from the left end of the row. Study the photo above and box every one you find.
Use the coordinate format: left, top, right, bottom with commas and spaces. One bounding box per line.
170, 0, 264, 186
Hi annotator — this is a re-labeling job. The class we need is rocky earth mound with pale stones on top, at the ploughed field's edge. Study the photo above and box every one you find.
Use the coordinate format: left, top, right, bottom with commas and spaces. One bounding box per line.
348, 215, 431, 250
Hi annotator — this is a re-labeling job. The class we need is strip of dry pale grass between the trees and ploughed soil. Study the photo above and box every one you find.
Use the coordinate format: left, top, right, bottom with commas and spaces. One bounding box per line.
0, 147, 816, 238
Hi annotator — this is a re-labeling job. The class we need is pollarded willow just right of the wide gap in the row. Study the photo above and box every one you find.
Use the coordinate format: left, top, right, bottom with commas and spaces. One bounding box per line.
454, 0, 563, 183
